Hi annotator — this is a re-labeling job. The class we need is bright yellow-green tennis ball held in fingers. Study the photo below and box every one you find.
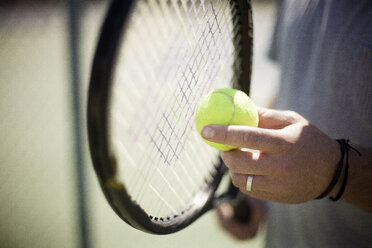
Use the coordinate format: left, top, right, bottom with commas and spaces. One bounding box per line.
195, 88, 258, 151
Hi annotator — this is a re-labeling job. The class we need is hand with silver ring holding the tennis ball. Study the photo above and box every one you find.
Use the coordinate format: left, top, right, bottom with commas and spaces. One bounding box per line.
202, 109, 341, 203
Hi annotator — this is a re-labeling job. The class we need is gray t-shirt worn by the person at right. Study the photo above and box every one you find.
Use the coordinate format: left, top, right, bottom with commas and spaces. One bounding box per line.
266, 0, 372, 247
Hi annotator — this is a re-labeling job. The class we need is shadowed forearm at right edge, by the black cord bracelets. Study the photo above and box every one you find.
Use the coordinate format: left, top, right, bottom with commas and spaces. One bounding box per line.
330, 145, 372, 212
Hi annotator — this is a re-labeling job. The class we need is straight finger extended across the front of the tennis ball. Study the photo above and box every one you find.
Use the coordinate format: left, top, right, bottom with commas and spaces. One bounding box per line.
201, 125, 285, 151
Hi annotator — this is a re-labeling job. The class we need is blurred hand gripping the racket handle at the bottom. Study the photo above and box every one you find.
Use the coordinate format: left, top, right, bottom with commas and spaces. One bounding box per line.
217, 196, 265, 240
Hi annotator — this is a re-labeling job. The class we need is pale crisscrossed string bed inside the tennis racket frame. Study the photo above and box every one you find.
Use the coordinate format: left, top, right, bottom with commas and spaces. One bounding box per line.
112, 0, 241, 216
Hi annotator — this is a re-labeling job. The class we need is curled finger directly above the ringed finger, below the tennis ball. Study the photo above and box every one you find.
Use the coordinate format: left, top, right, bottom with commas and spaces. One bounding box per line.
221, 149, 275, 175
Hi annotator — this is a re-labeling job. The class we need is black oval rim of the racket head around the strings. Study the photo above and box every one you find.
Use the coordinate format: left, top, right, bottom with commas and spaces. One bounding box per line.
87, 0, 253, 234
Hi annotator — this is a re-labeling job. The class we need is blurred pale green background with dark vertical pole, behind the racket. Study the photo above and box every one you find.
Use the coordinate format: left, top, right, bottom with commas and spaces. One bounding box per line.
0, 0, 278, 248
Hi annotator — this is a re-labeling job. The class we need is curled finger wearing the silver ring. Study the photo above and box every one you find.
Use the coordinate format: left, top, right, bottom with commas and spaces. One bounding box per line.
230, 171, 270, 193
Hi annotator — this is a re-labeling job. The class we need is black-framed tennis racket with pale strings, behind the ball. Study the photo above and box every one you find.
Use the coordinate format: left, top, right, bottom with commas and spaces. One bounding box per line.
88, 0, 253, 234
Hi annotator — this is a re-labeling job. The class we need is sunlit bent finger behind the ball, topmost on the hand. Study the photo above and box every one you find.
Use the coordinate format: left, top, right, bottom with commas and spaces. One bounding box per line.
257, 107, 305, 129
